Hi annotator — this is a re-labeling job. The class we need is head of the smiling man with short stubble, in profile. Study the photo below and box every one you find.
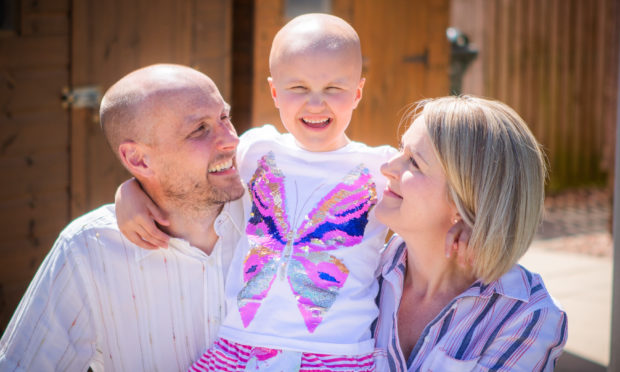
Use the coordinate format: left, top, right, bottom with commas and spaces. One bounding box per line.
100, 64, 243, 211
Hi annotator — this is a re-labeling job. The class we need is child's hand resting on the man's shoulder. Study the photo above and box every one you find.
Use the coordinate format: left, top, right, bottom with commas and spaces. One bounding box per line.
114, 178, 170, 249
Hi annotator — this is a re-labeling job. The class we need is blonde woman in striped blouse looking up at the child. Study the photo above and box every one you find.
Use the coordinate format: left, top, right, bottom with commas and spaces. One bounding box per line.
374, 96, 567, 371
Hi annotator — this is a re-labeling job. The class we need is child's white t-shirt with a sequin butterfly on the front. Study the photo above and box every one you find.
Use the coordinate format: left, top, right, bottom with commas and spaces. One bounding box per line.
220, 125, 395, 355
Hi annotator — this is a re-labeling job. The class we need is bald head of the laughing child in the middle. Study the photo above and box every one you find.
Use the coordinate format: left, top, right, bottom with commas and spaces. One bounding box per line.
268, 14, 364, 151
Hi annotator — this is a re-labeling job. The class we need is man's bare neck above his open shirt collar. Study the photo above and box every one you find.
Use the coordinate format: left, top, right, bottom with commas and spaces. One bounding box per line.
164, 204, 223, 254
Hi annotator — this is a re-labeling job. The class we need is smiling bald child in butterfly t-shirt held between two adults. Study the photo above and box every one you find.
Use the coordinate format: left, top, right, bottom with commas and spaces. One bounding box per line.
117, 14, 464, 371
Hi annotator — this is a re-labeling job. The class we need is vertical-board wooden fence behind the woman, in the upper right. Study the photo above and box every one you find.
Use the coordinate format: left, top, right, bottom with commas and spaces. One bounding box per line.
451, 0, 620, 191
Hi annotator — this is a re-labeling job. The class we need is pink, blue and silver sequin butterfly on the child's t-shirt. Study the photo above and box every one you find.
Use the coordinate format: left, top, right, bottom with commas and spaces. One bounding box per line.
237, 152, 377, 333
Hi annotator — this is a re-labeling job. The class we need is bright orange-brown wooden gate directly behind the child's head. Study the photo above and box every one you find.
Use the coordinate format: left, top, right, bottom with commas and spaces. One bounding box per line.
252, 0, 450, 146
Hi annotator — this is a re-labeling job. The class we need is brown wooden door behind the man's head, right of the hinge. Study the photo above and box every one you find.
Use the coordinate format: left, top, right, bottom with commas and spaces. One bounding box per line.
71, 0, 232, 217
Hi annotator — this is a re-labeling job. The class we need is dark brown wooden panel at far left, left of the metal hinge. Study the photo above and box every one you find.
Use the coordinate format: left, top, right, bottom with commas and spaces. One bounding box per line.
0, 0, 69, 330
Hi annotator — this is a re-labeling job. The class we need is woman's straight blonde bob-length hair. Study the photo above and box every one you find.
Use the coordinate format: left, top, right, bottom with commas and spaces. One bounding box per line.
407, 96, 547, 283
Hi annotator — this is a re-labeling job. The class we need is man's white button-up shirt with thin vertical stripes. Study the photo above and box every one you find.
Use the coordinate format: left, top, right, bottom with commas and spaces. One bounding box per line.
0, 202, 243, 371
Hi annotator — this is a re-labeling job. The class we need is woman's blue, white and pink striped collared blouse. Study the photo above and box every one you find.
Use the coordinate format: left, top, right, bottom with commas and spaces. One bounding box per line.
373, 236, 567, 371
